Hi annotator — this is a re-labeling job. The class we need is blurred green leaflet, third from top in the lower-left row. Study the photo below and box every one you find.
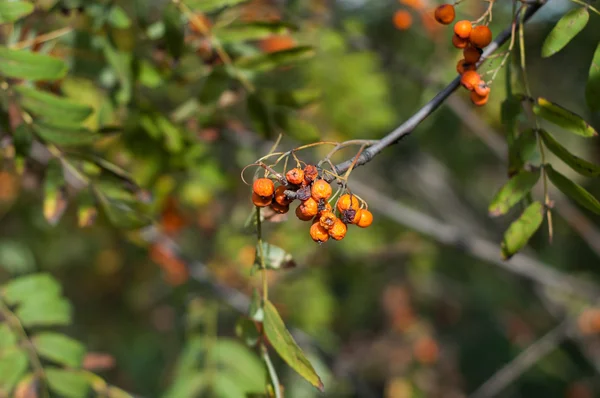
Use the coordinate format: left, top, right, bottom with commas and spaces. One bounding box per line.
32, 332, 85, 368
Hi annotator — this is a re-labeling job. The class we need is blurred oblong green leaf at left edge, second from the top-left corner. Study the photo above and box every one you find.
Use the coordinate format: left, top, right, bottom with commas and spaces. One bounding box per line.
0, 46, 67, 80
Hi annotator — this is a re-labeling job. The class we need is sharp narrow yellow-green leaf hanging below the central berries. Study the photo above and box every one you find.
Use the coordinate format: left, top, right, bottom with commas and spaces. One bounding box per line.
263, 300, 323, 391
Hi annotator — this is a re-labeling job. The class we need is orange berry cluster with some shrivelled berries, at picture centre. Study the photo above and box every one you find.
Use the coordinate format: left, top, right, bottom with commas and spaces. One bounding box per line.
252, 164, 373, 243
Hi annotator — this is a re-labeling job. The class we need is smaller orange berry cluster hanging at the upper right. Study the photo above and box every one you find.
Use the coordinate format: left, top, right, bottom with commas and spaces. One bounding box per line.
434, 4, 492, 106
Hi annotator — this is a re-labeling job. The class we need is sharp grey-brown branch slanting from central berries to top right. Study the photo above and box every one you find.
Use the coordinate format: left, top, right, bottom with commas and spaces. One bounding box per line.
335, 1, 545, 175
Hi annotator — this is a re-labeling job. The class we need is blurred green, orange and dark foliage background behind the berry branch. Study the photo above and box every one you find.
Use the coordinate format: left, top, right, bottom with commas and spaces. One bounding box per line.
0, 0, 600, 398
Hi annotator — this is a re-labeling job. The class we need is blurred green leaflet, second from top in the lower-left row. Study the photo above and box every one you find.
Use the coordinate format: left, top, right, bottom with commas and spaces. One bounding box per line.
16, 297, 72, 328
